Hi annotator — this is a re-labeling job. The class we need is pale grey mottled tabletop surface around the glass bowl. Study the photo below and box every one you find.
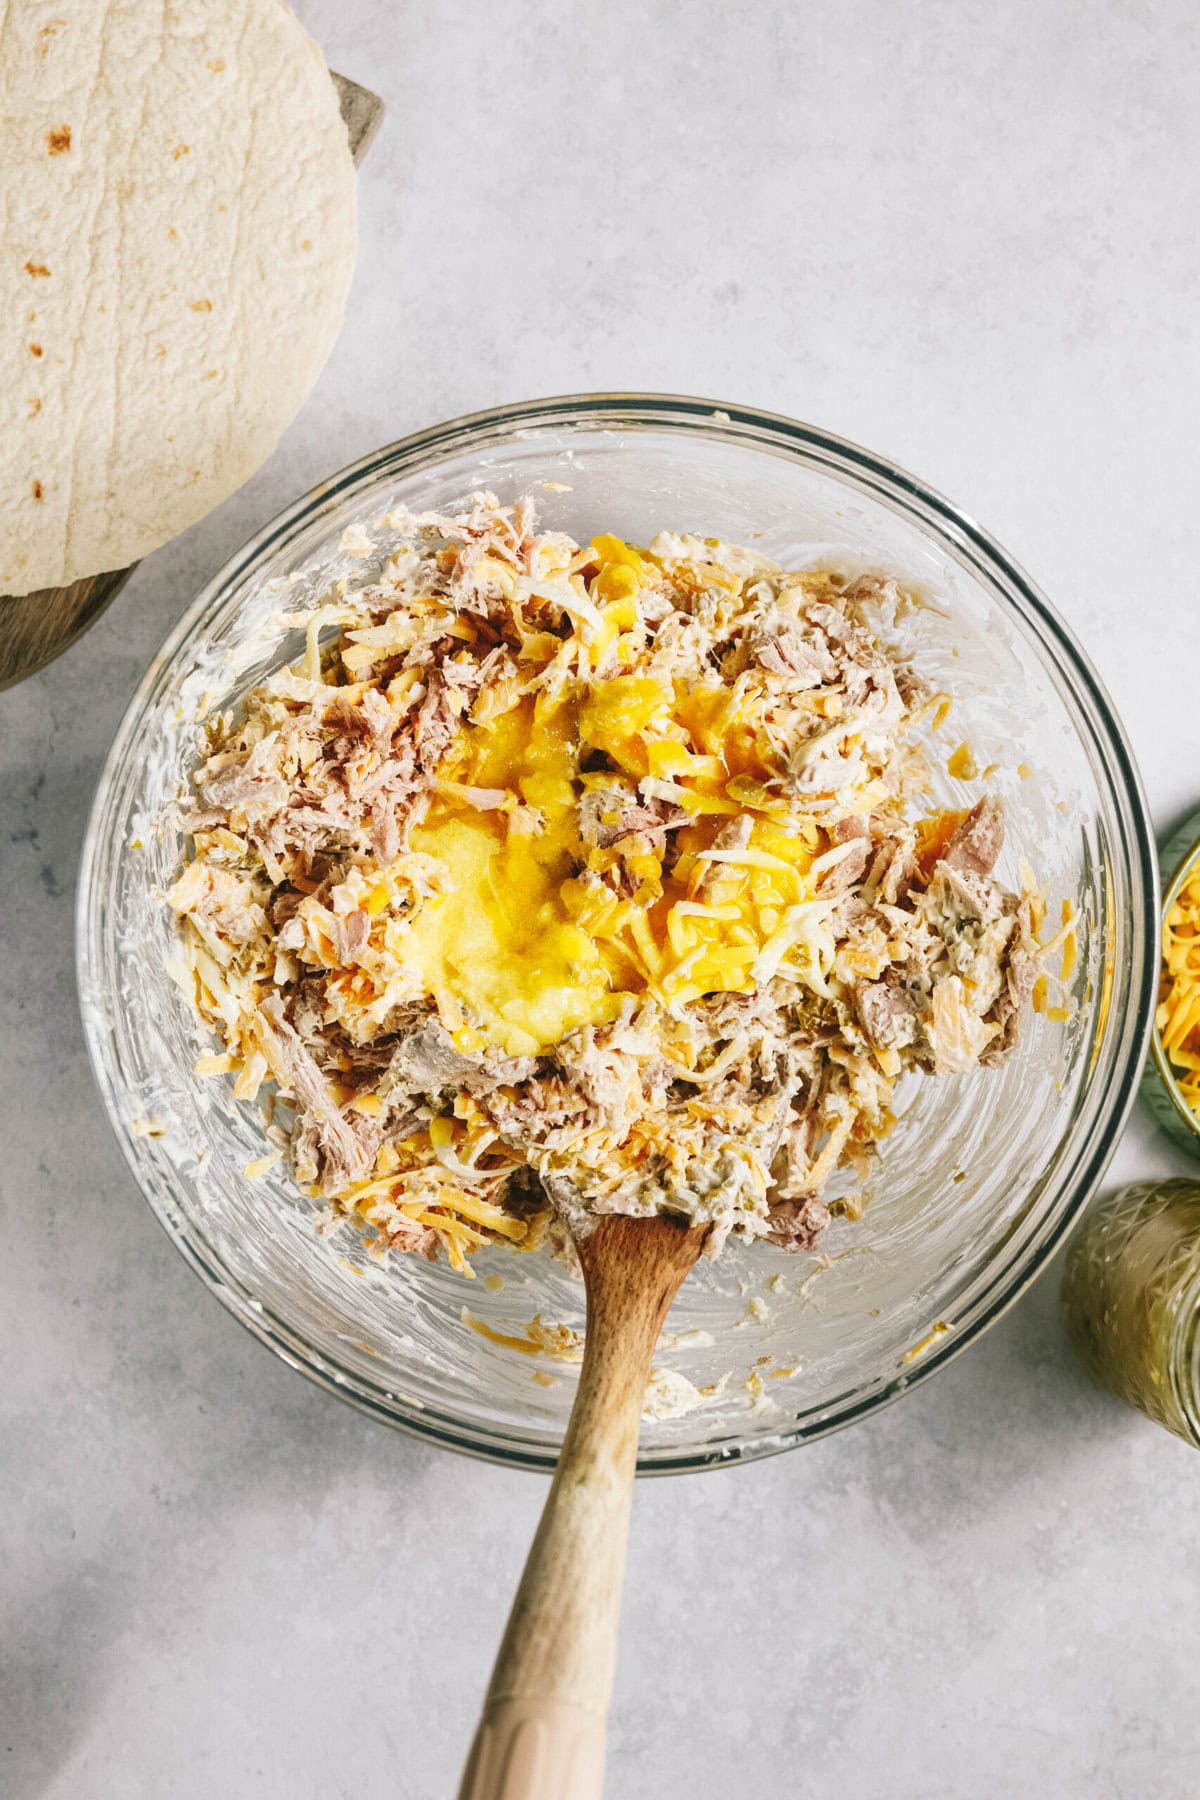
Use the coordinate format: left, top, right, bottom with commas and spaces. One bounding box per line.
0, 0, 1200, 1800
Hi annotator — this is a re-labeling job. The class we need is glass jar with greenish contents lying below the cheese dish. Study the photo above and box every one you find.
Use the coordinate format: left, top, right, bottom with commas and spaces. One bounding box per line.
1063, 1181, 1200, 1449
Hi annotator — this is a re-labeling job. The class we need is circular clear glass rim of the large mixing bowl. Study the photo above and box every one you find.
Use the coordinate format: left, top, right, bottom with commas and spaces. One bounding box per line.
76, 391, 1160, 1476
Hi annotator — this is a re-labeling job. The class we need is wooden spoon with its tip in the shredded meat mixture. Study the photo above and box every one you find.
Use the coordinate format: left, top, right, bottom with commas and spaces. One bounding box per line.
459, 1215, 711, 1800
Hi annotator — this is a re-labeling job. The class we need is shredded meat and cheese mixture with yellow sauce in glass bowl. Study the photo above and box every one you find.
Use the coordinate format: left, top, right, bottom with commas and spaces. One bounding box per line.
169, 495, 1050, 1273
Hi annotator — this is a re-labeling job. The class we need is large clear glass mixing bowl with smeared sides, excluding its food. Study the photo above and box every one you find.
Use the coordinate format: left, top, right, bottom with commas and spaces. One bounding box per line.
79, 394, 1157, 1472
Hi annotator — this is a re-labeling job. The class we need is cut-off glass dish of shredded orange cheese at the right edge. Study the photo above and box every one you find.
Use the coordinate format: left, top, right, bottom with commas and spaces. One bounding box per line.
1142, 812, 1200, 1156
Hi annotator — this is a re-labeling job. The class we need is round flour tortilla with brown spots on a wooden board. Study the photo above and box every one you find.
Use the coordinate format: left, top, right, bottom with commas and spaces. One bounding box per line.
0, 0, 356, 594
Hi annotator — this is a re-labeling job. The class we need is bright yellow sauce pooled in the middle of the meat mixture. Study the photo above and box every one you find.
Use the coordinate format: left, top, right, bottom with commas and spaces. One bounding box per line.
407, 666, 831, 1055
